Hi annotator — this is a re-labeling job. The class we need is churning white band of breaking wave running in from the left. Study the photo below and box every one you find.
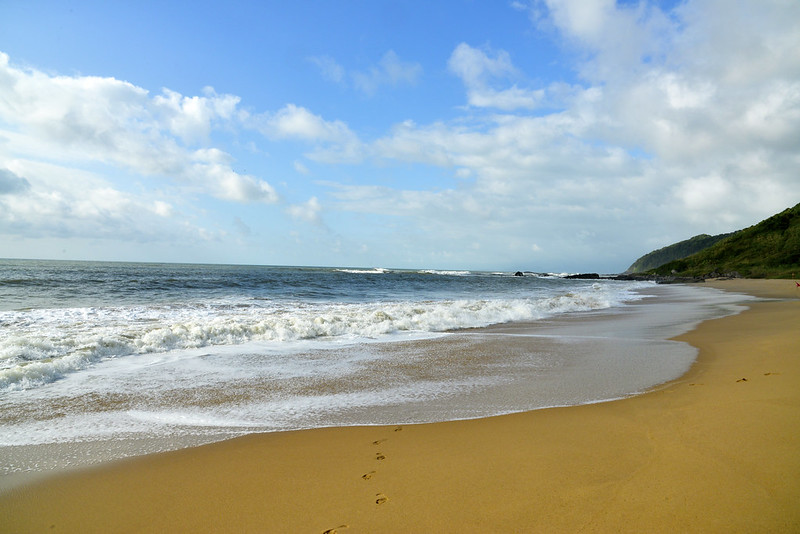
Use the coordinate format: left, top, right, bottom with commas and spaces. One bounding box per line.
0, 284, 635, 390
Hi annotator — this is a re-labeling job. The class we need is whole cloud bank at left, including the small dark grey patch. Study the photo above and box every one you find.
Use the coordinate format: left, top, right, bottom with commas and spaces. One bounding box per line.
0, 53, 278, 254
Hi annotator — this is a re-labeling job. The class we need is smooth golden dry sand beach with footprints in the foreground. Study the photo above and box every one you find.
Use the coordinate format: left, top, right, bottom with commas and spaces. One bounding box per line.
0, 280, 800, 533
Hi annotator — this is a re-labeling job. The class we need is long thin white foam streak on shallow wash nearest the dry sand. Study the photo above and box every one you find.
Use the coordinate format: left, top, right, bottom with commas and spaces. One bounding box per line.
0, 372, 496, 452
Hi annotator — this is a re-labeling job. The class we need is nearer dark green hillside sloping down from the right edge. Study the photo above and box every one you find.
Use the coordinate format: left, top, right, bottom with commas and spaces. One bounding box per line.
650, 204, 800, 278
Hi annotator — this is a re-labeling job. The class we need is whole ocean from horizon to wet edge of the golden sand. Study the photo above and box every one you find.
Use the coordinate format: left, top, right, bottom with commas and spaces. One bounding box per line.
0, 260, 744, 475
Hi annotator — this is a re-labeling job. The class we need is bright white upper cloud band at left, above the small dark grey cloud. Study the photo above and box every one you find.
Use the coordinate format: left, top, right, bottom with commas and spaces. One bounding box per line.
0, 54, 276, 207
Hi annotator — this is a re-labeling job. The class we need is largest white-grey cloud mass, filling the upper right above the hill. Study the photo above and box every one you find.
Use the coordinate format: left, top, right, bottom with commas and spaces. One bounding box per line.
364, 0, 800, 245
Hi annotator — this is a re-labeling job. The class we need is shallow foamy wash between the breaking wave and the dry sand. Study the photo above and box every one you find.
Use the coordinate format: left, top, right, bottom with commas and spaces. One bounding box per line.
0, 284, 724, 482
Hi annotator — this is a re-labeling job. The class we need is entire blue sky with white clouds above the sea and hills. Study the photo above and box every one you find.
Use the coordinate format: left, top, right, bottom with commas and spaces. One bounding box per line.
0, 0, 800, 273
